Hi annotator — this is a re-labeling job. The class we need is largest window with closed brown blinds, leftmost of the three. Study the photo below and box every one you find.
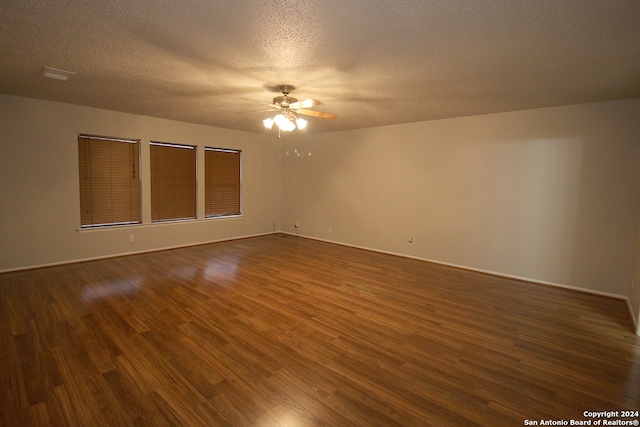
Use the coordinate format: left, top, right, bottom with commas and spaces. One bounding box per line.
78, 135, 140, 228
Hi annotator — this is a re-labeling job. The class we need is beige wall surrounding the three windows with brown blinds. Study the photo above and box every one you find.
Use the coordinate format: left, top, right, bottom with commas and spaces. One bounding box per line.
0, 95, 281, 271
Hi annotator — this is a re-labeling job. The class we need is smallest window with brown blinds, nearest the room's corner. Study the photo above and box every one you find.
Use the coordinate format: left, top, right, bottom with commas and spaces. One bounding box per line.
204, 147, 240, 217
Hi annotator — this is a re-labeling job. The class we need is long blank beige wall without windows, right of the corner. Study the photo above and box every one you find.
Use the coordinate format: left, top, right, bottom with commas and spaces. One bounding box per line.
282, 99, 640, 297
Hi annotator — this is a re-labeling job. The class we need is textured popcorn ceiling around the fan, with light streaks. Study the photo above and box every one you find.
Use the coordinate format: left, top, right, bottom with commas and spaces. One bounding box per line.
0, 0, 640, 133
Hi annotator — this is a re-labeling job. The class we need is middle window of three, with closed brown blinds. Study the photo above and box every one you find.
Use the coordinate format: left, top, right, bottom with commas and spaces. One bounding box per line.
150, 142, 196, 222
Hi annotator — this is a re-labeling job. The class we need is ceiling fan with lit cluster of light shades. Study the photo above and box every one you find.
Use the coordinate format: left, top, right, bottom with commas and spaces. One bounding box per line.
262, 85, 337, 132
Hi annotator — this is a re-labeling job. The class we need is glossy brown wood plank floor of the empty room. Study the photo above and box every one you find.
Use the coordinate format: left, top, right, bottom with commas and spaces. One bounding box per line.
0, 235, 640, 427
